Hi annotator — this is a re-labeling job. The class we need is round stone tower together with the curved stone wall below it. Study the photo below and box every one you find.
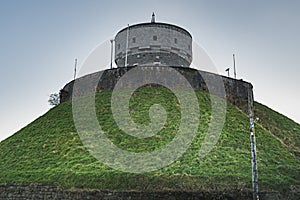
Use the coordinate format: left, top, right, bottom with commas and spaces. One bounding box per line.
60, 14, 253, 108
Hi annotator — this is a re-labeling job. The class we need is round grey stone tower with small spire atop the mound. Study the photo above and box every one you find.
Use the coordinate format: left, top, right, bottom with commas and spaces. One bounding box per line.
115, 13, 193, 67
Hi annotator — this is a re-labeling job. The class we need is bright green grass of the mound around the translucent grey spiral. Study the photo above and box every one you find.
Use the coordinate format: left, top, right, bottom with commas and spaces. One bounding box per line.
0, 88, 300, 191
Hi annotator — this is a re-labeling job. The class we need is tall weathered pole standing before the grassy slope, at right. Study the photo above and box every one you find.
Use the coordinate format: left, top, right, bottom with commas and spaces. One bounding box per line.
248, 87, 259, 200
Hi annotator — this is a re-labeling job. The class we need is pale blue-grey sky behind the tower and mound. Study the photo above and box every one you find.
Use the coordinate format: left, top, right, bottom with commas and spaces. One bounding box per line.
0, 0, 300, 141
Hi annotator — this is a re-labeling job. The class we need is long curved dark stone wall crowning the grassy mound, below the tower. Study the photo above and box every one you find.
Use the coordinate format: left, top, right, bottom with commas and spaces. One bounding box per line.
60, 66, 253, 106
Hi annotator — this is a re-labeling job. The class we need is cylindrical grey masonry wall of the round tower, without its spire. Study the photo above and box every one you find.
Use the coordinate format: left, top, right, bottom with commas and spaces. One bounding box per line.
115, 23, 193, 67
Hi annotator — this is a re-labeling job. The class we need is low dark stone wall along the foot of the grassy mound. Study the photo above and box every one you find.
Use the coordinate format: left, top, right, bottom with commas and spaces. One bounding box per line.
0, 183, 300, 200
